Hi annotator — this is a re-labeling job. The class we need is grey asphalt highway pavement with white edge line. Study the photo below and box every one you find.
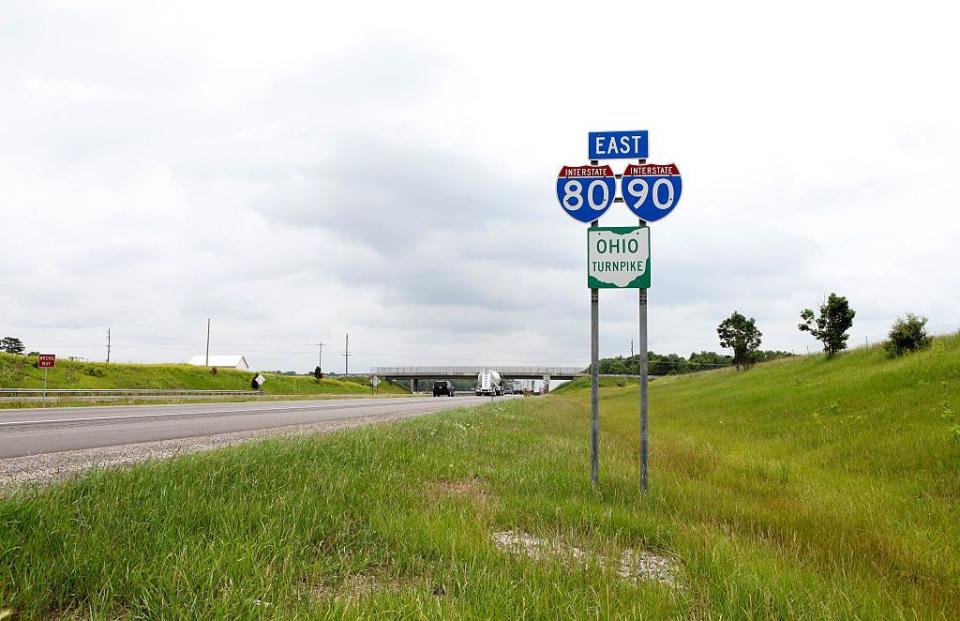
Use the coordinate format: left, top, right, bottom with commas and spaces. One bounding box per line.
0, 397, 490, 459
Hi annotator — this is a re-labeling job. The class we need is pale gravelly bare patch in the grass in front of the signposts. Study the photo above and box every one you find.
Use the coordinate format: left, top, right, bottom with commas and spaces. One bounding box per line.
491, 530, 680, 588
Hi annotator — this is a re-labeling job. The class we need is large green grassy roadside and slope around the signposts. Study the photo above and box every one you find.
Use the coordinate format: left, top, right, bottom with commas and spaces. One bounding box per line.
0, 337, 960, 619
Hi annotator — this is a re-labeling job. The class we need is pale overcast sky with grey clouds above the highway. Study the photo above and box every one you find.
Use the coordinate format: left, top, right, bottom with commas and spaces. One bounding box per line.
0, 0, 960, 371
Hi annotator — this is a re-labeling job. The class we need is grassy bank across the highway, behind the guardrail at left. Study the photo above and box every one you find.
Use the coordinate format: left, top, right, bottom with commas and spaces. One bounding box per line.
0, 353, 407, 404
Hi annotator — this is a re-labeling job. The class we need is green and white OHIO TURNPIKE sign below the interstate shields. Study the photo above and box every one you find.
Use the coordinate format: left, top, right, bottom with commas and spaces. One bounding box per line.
587, 226, 650, 289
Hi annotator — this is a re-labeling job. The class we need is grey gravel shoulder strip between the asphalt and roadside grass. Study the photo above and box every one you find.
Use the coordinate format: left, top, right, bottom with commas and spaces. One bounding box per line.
0, 409, 435, 492
